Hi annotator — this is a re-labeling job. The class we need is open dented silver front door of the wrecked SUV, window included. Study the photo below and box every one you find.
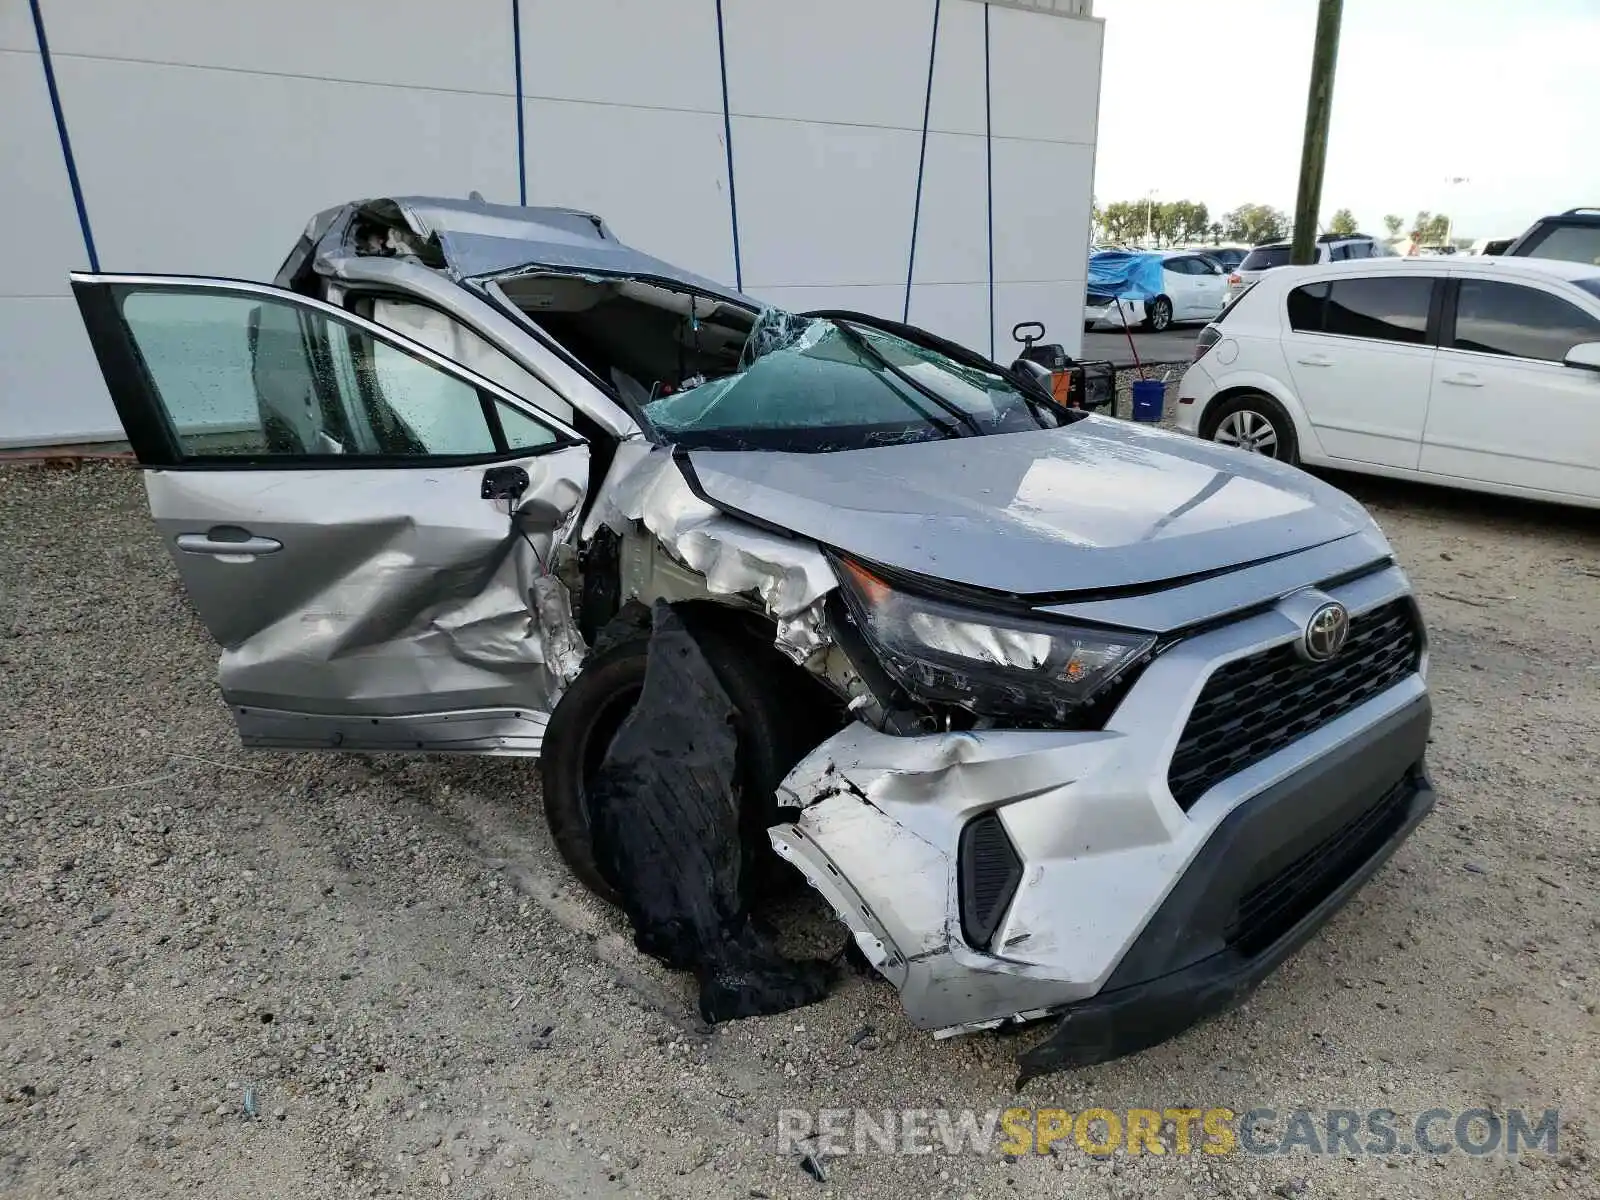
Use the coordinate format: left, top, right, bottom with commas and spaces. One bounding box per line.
72, 275, 589, 754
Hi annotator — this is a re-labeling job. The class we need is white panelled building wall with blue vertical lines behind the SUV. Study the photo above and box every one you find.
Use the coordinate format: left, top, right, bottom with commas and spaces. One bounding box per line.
0, 0, 1101, 445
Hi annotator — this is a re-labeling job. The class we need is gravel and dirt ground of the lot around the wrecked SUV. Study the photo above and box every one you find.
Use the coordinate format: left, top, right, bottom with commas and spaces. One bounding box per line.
0, 467, 1600, 1200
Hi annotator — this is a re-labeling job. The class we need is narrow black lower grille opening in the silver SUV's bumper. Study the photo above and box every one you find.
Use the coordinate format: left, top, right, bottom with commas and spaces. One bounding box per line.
1222, 774, 1416, 955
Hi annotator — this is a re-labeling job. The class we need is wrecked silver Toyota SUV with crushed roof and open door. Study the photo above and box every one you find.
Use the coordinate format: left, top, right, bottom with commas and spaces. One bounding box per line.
74, 198, 1434, 1069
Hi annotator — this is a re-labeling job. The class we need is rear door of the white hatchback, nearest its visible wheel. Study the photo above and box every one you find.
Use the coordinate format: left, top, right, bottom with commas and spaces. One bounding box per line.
1283, 270, 1443, 470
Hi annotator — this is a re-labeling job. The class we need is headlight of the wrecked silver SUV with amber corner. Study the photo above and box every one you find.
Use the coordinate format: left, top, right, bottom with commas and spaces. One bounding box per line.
835, 560, 1155, 722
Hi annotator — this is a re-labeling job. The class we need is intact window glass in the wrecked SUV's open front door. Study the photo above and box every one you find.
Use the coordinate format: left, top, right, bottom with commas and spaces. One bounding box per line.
122, 291, 515, 458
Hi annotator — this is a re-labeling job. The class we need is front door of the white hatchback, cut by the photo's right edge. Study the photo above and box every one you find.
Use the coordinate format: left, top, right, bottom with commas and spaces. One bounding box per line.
1422, 277, 1600, 498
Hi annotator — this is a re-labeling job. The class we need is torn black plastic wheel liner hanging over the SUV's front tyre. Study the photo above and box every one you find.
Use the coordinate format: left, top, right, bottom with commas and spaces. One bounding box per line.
587, 602, 834, 1022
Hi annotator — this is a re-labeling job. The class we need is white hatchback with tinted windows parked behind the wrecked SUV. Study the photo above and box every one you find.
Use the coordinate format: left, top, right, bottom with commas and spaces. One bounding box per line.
1178, 254, 1600, 507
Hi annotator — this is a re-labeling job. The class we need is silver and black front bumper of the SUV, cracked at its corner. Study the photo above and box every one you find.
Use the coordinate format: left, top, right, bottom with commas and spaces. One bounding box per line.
771, 568, 1432, 1074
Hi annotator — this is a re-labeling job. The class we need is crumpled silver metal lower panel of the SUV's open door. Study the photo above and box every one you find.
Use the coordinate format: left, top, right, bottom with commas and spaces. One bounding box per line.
146, 446, 589, 747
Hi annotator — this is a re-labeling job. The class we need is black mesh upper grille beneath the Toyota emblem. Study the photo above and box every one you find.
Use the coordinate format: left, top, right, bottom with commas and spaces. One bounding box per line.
1166, 597, 1422, 811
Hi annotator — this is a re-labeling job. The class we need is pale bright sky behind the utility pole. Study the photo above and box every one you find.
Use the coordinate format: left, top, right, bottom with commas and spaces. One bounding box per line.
1094, 0, 1600, 238
